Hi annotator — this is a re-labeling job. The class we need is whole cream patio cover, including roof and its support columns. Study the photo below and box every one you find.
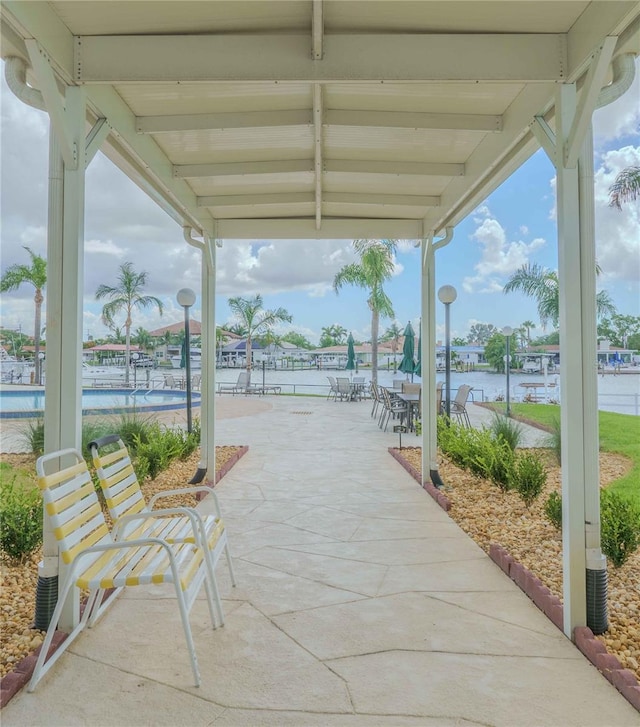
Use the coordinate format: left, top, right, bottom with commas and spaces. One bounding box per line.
0, 0, 640, 636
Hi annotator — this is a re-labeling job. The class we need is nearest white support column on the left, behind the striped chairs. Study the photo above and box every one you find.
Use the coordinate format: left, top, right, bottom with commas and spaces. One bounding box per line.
39, 87, 86, 630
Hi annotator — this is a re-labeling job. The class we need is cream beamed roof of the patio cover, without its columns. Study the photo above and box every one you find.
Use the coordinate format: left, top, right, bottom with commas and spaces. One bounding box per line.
1, 0, 638, 238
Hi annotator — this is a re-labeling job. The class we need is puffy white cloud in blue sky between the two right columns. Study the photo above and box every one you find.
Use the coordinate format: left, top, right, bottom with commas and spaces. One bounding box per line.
463, 216, 546, 293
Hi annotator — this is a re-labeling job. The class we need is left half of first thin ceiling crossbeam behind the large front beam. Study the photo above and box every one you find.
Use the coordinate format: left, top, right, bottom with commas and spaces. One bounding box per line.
136, 109, 313, 134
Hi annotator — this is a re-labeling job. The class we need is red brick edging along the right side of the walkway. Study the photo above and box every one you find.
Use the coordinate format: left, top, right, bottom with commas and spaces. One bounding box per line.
389, 447, 640, 712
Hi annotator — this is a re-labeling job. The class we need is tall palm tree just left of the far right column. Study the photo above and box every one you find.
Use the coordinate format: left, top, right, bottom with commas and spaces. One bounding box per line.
333, 240, 396, 384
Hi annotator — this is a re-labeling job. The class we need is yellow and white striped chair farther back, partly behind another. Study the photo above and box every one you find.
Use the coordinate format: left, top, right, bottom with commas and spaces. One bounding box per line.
89, 434, 236, 625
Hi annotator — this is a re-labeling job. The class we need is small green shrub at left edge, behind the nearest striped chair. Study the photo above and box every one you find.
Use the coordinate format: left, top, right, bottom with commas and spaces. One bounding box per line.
0, 475, 42, 560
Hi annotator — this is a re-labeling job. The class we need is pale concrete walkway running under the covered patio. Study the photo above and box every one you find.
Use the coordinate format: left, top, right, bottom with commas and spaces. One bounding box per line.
2, 397, 639, 727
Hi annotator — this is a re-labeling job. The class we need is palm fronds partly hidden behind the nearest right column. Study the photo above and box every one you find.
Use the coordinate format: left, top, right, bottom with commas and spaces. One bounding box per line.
503, 263, 616, 328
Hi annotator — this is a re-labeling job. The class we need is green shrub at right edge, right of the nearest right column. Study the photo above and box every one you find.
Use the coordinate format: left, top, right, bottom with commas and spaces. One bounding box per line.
600, 490, 640, 568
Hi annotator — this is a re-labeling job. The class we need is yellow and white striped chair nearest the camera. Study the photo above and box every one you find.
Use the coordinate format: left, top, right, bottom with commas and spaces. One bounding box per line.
29, 449, 216, 692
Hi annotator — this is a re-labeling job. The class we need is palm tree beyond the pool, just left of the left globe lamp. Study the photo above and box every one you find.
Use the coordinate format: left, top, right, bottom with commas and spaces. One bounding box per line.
96, 262, 163, 385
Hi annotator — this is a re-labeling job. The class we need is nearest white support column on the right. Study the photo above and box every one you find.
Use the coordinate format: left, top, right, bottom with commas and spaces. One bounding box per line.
556, 84, 598, 638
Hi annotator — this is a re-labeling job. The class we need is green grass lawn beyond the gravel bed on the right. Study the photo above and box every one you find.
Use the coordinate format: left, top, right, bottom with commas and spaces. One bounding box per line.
492, 403, 640, 507
